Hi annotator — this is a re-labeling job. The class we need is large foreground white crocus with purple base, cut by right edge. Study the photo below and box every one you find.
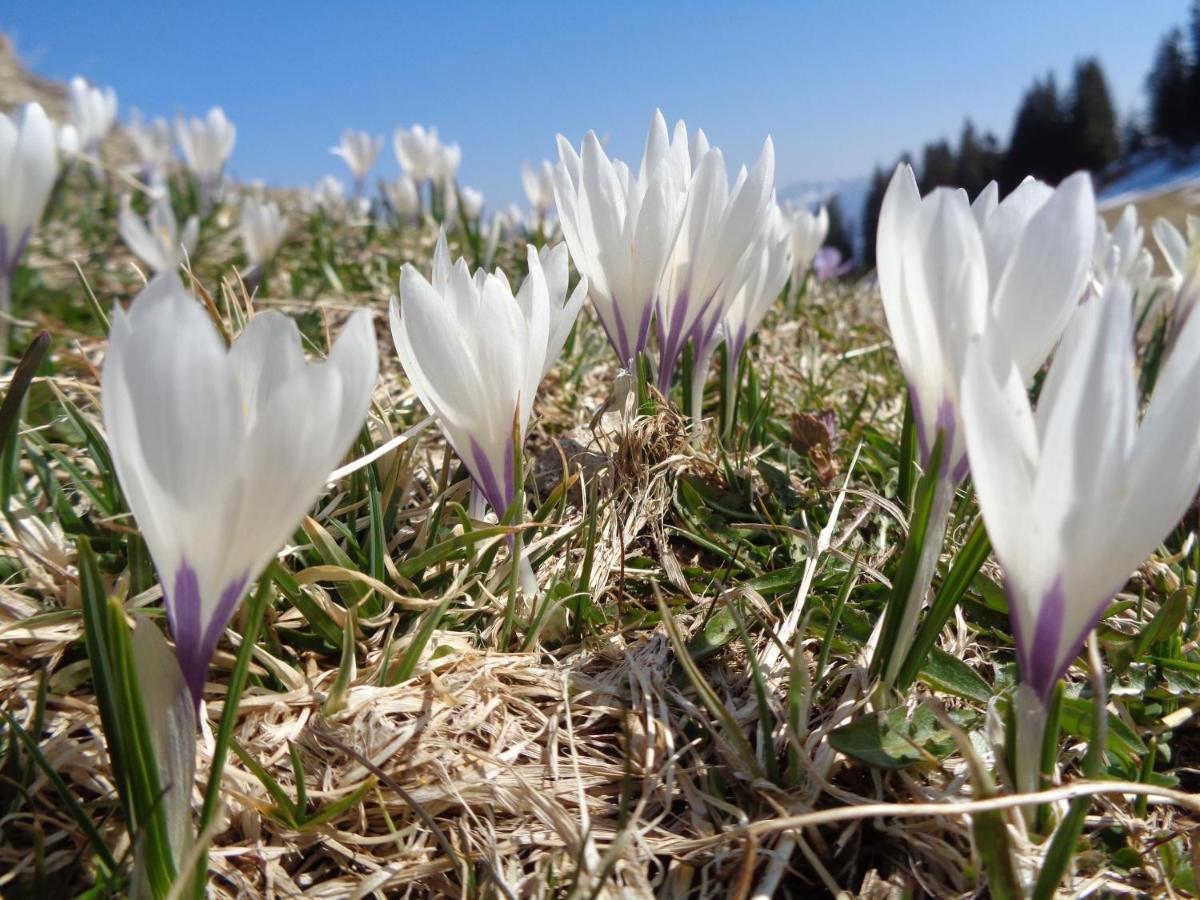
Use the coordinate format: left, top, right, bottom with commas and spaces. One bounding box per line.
962, 278, 1200, 790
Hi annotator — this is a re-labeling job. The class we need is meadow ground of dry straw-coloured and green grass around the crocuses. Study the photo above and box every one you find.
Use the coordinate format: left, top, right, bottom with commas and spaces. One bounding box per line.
0, 51, 1200, 898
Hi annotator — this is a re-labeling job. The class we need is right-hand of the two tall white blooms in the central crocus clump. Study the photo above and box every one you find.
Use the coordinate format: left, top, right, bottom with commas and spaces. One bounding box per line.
647, 114, 775, 394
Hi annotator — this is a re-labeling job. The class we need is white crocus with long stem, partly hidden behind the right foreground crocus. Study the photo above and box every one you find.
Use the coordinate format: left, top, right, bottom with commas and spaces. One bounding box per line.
876, 163, 1096, 683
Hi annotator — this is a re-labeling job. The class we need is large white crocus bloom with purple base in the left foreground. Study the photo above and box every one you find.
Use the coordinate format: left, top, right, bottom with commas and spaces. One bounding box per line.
101, 272, 378, 704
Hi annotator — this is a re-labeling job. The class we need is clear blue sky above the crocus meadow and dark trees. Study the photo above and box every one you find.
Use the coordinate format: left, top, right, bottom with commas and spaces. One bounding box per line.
0, 0, 1188, 206
